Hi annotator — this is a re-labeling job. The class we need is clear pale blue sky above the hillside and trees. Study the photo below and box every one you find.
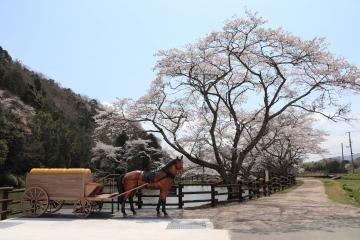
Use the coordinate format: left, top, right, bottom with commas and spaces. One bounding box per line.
0, 0, 360, 161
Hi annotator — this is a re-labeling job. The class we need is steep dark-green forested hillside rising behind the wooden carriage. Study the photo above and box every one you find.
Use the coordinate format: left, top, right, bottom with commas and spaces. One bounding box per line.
0, 47, 97, 185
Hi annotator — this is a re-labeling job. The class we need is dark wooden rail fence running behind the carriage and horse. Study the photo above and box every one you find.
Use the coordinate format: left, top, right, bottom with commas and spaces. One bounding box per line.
0, 175, 296, 220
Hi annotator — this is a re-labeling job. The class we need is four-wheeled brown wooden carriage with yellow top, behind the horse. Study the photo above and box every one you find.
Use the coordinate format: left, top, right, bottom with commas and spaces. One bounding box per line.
22, 168, 117, 218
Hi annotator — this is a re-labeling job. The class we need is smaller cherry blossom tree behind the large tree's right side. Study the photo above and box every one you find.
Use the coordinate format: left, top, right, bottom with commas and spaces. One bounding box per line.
249, 111, 327, 176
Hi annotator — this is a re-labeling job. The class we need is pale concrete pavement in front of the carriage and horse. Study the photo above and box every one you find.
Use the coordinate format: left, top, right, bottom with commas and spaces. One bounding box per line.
0, 218, 230, 240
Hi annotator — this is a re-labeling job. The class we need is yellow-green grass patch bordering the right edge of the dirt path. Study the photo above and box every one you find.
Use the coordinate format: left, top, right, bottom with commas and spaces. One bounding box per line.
323, 179, 360, 207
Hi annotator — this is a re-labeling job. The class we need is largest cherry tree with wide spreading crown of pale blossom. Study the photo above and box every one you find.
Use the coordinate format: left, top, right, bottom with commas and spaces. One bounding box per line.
116, 14, 360, 183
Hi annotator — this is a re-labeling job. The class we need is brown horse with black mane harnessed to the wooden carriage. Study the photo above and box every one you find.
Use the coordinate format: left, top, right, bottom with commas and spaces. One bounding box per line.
117, 157, 184, 216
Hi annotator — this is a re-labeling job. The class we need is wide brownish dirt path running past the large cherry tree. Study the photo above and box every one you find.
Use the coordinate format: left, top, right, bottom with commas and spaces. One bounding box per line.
183, 179, 360, 240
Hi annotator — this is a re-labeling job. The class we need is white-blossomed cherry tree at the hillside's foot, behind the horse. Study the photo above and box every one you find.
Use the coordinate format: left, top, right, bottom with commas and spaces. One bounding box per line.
91, 106, 169, 175
